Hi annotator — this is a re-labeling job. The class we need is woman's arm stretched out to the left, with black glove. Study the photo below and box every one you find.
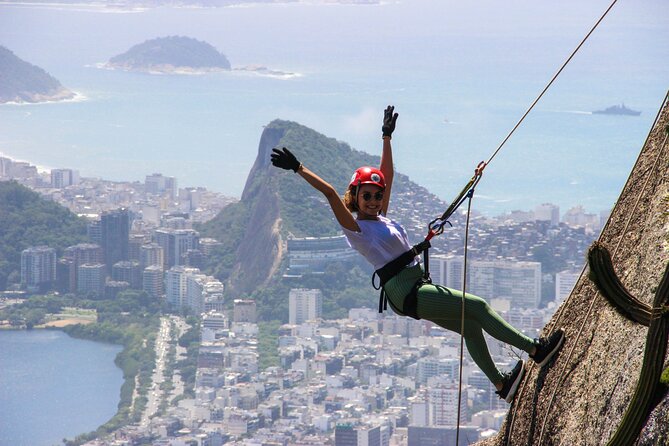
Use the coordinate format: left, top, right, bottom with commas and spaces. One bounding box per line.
272, 147, 360, 232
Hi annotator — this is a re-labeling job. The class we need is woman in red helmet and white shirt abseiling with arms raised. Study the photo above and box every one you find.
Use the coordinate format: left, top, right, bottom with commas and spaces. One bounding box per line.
271, 106, 565, 402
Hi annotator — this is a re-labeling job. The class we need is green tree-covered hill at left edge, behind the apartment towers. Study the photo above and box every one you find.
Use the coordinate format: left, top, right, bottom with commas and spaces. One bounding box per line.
0, 181, 87, 290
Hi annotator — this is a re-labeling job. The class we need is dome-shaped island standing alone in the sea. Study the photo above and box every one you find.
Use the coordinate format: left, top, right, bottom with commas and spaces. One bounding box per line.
106, 36, 230, 73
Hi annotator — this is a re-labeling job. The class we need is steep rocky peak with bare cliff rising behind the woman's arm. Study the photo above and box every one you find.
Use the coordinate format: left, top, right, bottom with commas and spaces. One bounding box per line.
199, 120, 445, 293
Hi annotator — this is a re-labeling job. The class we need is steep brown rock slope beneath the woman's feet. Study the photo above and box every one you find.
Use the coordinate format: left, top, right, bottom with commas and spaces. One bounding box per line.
481, 92, 669, 446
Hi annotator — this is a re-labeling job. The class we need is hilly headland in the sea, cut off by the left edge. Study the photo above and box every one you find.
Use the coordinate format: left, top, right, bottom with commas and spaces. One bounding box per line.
0, 46, 75, 104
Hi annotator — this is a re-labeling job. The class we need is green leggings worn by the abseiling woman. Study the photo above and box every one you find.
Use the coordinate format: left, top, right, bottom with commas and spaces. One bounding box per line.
384, 265, 534, 384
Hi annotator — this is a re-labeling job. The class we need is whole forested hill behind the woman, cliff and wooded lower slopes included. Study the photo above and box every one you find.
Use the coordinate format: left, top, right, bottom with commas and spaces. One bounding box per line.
198, 120, 441, 319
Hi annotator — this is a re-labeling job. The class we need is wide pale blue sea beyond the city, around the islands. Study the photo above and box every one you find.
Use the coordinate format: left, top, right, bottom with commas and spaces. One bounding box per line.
0, 0, 669, 214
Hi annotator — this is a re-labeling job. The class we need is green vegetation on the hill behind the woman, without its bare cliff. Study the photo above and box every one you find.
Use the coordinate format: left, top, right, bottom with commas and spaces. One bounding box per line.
197, 120, 396, 322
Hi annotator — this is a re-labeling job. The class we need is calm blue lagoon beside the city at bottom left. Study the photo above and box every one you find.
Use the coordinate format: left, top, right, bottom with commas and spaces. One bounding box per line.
0, 330, 123, 446
